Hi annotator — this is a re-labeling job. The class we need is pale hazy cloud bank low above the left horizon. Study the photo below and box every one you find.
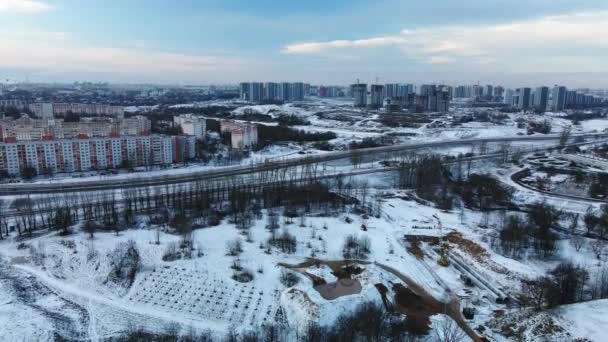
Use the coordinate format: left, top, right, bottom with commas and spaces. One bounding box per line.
0, 32, 251, 82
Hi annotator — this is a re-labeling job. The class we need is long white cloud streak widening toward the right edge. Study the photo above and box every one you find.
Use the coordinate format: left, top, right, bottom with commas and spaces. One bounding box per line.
282, 11, 608, 72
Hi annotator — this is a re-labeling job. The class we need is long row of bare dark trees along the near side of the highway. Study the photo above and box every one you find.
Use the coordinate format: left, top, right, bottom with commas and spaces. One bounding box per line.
0, 166, 350, 239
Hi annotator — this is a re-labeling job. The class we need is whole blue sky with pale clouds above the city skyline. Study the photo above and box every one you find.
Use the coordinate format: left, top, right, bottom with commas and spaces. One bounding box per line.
0, 0, 608, 88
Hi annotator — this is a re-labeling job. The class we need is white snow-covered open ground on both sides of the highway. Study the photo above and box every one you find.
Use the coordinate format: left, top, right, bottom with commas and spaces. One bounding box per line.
0, 100, 608, 341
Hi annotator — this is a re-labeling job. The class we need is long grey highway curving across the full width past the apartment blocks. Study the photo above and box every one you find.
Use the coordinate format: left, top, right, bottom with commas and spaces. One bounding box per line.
0, 133, 608, 196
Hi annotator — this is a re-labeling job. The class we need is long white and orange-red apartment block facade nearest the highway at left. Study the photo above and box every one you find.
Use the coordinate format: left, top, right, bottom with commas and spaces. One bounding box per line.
0, 135, 195, 176
